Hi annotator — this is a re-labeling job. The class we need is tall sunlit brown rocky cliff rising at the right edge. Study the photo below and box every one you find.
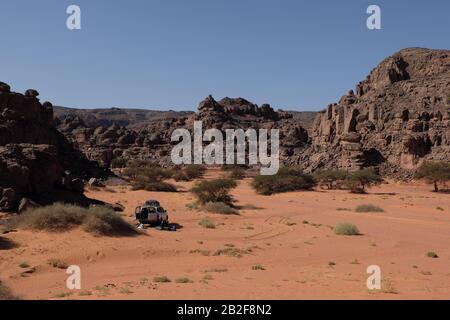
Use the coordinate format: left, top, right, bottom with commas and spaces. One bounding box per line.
304, 48, 450, 176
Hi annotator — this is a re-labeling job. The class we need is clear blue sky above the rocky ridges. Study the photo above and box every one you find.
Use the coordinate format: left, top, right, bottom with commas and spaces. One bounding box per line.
0, 0, 450, 110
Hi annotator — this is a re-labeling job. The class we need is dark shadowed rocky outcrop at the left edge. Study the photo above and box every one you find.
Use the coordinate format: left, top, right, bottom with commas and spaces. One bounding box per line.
0, 82, 103, 210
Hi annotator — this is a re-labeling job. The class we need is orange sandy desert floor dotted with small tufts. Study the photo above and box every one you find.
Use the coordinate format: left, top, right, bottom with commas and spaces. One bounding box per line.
0, 170, 450, 299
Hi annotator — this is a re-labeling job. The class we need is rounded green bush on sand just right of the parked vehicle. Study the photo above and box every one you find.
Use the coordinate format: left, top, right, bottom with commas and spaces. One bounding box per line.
192, 179, 237, 204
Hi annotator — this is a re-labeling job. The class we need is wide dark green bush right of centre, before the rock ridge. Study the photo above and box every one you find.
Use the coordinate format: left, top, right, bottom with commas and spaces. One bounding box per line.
252, 167, 316, 195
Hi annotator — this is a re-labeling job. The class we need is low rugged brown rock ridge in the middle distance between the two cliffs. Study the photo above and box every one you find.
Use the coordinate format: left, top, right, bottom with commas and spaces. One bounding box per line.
56, 96, 309, 167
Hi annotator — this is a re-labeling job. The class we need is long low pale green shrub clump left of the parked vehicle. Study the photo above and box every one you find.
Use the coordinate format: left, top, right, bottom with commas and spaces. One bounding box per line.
11, 203, 137, 236
